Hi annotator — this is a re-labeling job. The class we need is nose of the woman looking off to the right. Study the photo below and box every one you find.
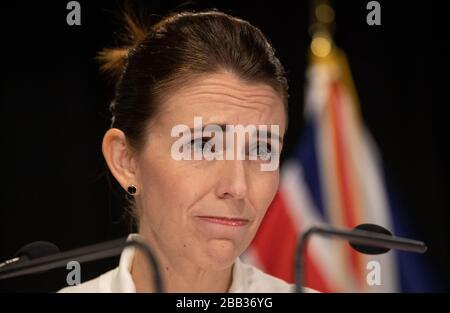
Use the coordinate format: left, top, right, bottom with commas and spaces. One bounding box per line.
216, 160, 248, 200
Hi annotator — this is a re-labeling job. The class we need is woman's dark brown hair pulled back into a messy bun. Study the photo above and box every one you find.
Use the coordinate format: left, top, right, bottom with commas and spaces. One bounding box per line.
98, 11, 288, 150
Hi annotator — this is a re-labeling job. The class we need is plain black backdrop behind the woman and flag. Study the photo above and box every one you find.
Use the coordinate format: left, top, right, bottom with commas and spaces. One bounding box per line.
0, 0, 450, 291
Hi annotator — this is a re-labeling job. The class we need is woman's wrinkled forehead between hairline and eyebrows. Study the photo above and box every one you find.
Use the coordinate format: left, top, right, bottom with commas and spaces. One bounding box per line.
158, 72, 286, 132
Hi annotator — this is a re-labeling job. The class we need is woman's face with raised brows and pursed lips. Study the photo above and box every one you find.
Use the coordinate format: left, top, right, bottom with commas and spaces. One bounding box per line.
136, 72, 286, 270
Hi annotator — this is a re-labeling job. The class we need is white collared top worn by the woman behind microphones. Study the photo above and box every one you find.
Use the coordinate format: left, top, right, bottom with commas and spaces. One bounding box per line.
59, 234, 312, 293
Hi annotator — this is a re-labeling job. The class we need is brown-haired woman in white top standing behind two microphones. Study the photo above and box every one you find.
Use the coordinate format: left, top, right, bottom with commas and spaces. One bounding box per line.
59, 11, 310, 292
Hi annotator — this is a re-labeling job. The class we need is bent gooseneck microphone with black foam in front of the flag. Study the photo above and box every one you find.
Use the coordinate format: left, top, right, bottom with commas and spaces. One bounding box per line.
294, 224, 427, 293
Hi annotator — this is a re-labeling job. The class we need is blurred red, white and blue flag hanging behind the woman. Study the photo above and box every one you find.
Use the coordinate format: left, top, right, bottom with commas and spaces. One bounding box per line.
243, 47, 400, 292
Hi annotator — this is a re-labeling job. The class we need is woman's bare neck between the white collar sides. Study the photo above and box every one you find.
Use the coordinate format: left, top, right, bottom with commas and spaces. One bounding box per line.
131, 232, 232, 293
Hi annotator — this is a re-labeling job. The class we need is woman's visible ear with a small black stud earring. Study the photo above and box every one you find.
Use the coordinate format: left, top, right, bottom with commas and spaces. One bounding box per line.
102, 128, 140, 195
